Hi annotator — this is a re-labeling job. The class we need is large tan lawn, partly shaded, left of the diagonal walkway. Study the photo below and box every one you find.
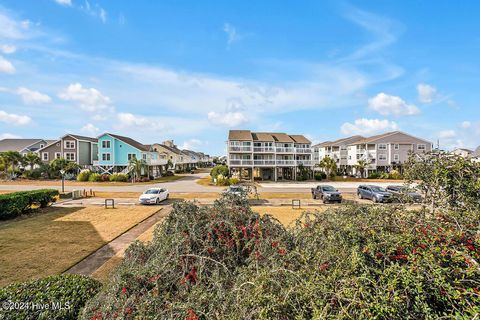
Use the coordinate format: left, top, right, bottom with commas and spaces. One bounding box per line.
0, 207, 159, 286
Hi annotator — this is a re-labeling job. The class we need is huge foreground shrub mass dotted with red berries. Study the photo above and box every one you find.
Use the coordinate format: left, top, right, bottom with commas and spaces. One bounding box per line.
81, 195, 480, 319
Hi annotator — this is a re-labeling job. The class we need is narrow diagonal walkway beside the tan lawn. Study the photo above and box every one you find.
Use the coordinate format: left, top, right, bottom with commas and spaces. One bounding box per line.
65, 205, 172, 275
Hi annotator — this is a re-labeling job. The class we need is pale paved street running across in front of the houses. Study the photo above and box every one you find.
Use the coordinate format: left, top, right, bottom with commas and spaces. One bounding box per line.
0, 173, 406, 193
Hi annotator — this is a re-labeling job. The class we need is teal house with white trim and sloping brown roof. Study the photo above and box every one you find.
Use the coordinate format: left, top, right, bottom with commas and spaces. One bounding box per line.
94, 133, 166, 174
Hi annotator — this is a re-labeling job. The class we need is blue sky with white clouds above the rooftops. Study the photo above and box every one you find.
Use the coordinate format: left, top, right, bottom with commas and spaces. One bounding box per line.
0, 0, 480, 154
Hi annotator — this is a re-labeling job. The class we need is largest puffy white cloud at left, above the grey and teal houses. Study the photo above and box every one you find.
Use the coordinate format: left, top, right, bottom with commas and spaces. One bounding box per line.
58, 83, 113, 112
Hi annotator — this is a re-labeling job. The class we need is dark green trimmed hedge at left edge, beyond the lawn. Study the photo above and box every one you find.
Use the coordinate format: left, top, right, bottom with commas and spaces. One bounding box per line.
0, 189, 58, 220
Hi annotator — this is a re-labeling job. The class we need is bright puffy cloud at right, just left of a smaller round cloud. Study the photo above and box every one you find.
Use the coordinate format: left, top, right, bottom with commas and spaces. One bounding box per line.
368, 92, 420, 116
